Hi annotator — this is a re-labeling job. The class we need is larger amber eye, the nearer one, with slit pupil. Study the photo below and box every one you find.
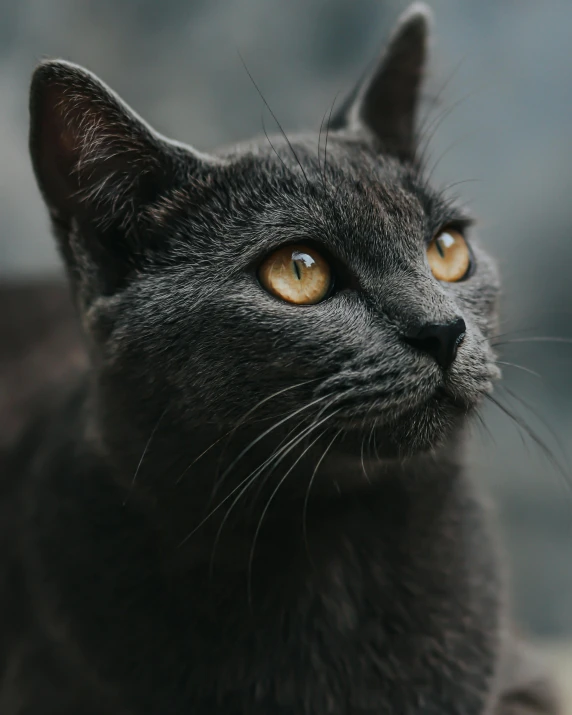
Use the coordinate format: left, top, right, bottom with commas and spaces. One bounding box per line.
258, 245, 332, 305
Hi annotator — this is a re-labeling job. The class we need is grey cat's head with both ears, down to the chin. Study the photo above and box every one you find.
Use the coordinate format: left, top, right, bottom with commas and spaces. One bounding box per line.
30, 5, 497, 482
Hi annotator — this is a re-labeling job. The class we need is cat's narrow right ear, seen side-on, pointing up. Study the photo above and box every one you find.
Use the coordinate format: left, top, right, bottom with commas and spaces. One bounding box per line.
330, 3, 432, 161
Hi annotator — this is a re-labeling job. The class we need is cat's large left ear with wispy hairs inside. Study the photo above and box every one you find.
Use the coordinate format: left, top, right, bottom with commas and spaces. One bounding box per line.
30, 61, 212, 298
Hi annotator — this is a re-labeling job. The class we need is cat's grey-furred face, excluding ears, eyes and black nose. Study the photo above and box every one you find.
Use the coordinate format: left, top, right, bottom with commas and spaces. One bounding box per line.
89, 137, 496, 453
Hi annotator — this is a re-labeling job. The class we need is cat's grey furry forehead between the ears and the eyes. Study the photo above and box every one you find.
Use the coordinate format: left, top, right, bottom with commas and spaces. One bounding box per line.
149, 132, 470, 276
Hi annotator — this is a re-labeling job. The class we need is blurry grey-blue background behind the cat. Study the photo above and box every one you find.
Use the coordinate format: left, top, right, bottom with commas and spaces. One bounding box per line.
0, 0, 572, 638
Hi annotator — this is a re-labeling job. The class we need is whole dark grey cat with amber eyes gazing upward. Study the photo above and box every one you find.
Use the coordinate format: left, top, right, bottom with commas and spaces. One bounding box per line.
0, 4, 558, 715
